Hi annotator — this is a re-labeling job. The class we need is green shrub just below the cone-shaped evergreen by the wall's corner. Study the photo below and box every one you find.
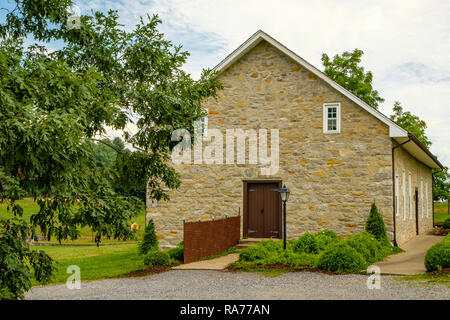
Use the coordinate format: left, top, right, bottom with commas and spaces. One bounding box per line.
345, 232, 386, 263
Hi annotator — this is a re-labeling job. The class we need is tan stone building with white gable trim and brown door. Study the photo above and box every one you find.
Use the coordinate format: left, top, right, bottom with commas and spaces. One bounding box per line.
147, 31, 442, 248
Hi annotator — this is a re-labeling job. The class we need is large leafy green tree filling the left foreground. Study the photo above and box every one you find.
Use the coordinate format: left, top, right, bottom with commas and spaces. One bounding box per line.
0, 0, 221, 298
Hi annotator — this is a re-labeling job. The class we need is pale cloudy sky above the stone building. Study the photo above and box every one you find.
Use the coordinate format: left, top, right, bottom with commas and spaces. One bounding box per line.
1, 0, 450, 166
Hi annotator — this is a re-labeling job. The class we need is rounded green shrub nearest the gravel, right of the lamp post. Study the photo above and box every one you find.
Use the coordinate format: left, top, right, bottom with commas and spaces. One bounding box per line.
316, 242, 367, 273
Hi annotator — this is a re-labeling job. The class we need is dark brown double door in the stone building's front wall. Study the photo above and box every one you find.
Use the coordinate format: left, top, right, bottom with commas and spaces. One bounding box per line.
247, 182, 281, 238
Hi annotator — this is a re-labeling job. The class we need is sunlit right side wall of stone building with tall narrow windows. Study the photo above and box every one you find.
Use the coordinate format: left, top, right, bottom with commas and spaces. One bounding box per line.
394, 142, 433, 245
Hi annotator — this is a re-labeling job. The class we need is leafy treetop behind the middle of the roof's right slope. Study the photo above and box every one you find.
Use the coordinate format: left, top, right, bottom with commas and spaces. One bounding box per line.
322, 49, 384, 109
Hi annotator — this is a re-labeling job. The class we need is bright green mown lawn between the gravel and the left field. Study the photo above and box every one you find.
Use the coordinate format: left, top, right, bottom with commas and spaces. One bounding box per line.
32, 244, 145, 284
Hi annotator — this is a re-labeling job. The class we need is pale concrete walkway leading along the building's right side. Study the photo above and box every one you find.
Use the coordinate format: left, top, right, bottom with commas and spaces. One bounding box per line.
376, 235, 444, 275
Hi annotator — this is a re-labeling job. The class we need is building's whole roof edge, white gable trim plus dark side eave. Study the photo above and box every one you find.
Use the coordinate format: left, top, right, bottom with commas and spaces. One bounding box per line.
213, 30, 442, 168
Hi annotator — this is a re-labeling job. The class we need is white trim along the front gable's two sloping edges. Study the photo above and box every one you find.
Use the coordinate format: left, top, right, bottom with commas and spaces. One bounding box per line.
213, 30, 408, 138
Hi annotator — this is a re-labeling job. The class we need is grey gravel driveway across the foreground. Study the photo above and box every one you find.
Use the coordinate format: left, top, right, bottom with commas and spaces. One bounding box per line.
26, 270, 450, 300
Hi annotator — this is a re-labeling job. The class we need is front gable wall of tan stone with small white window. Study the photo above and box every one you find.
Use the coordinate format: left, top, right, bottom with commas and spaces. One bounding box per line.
147, 41, 393, 248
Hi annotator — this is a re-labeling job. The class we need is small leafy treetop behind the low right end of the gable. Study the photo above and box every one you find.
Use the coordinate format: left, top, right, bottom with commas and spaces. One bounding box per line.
391, 101, 431, 148
